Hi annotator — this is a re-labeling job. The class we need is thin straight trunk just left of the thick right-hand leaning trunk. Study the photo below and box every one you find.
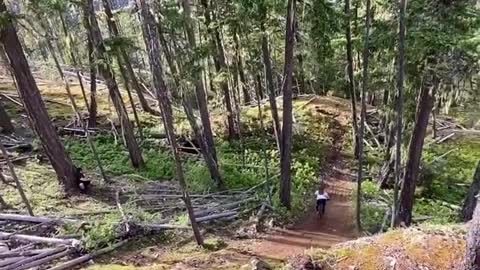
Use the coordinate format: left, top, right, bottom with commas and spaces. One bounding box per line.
391, 0, 406, 227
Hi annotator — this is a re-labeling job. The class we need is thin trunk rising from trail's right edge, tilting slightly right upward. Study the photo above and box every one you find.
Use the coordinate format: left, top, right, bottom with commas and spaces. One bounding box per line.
356, 0, 372, 231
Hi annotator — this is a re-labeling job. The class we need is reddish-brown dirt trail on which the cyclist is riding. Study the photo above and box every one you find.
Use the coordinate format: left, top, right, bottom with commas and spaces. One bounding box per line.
244, 119, 356, 261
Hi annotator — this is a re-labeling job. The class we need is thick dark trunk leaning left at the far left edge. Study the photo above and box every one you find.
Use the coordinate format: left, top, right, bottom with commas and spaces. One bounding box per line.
0, 1, 79, 193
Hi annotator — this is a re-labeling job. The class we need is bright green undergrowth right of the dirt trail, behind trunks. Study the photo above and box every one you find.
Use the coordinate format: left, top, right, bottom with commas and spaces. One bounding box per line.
361, 139, 480, 233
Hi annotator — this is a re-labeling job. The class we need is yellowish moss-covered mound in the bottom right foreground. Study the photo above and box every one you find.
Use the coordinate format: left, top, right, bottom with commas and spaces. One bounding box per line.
308, 226, 465, 270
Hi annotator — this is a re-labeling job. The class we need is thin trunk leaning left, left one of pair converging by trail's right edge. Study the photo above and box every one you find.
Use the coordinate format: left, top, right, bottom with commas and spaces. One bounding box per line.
345, 0, 359, 158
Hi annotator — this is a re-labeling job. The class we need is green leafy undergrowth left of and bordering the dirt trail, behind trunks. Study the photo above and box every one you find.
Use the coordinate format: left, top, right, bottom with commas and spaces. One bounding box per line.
62, 98, 334, 218
